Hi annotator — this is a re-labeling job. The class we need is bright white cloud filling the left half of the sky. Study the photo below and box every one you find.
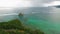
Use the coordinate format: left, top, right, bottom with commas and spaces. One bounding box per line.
0, 0, 31, 7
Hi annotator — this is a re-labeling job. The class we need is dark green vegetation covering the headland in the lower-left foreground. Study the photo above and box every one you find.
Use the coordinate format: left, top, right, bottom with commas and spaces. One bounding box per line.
0, 19, 44, 34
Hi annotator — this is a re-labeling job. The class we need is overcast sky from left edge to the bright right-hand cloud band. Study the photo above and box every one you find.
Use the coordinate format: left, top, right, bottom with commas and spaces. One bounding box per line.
0, 0, 57, 7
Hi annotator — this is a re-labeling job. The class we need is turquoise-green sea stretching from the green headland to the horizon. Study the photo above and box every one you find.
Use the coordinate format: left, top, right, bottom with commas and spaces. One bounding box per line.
0, 7, 60, 34
